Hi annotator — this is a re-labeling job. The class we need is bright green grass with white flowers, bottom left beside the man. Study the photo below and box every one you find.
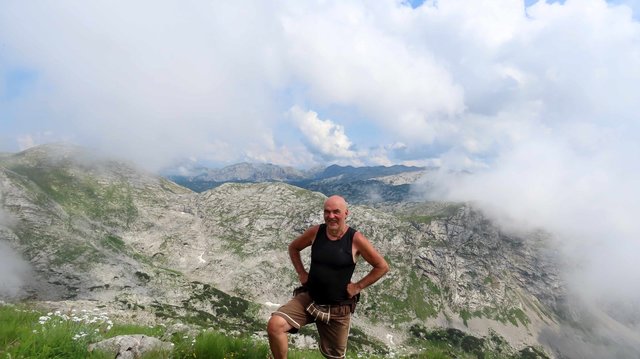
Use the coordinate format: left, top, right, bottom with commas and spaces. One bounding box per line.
0, 304, 364, 359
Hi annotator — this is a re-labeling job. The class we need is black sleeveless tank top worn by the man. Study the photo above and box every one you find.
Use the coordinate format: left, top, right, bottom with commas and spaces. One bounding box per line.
307, 224, 356, 305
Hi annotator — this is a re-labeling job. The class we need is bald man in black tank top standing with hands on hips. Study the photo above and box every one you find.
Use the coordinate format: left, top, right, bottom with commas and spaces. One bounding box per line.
267, 196, 389, 359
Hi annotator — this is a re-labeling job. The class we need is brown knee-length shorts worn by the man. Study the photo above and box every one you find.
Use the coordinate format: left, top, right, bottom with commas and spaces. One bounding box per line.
271, 292, 351, 358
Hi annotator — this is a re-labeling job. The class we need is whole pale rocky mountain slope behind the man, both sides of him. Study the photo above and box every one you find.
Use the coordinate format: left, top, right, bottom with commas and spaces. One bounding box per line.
0, 146, 563, 358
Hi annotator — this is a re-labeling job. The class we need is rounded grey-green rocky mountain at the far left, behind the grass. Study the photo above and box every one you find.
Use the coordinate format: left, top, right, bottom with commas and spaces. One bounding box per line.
0, 145, 262, 330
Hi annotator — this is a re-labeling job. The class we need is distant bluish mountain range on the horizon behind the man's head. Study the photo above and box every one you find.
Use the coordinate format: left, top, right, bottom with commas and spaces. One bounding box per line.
165, 163, 436, 204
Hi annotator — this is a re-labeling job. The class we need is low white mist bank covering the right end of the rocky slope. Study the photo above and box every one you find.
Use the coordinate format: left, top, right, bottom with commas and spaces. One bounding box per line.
422, 102, 640, 358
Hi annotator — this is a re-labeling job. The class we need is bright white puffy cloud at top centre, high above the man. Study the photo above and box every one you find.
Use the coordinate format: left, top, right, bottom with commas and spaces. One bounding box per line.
282, 2, 464, 143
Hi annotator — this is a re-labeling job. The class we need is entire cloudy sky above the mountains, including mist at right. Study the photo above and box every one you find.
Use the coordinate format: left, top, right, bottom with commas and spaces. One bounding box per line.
0, 0, 640, 344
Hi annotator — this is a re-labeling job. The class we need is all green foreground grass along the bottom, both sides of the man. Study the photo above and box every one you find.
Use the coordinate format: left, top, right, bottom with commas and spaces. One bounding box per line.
0, 302, 546, 359
